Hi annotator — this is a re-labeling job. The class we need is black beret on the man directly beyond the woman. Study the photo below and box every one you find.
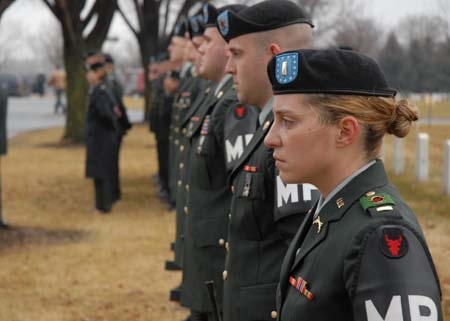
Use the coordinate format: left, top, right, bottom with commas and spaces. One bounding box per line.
216, 0, 314, 41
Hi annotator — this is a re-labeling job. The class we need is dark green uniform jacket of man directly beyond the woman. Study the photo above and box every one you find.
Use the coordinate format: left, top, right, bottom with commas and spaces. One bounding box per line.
223, 113, 313, 321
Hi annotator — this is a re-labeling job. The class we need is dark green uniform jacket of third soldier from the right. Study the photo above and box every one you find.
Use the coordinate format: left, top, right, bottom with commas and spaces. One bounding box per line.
180, 78, 237, 312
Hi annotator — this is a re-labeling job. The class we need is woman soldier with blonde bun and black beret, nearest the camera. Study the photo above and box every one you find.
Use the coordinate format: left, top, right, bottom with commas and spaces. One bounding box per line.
265, 50, 442, 321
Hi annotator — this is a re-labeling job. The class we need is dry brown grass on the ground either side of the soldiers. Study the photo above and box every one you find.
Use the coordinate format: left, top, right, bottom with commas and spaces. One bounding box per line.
0, 120, 450, 321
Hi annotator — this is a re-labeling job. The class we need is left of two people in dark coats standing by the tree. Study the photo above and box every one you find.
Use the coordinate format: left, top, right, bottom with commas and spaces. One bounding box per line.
86, 62, 119, 213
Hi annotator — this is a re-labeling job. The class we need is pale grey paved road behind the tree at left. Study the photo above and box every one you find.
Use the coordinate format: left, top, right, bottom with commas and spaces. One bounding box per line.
7, 95, 143, 138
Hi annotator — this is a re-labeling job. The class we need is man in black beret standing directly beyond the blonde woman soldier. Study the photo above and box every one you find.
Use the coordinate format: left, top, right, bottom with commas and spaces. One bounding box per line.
217, 0, 318, 321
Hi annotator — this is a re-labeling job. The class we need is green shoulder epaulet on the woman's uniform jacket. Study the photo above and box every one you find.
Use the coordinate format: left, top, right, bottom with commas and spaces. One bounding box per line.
359, 191, 401, 218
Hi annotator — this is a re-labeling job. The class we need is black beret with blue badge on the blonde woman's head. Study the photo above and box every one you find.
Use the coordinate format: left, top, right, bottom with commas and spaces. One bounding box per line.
267, 49, 397, 97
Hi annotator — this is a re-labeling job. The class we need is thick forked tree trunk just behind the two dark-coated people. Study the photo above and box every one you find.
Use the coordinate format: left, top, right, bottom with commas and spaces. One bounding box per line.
42, 0, 117, 142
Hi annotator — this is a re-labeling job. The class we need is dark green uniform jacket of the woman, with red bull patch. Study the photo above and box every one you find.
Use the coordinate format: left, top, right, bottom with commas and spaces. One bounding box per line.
273, 160, 442, 321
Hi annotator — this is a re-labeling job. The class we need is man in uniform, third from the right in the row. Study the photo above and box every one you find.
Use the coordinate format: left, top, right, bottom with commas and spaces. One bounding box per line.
180, 4, 245, 321
